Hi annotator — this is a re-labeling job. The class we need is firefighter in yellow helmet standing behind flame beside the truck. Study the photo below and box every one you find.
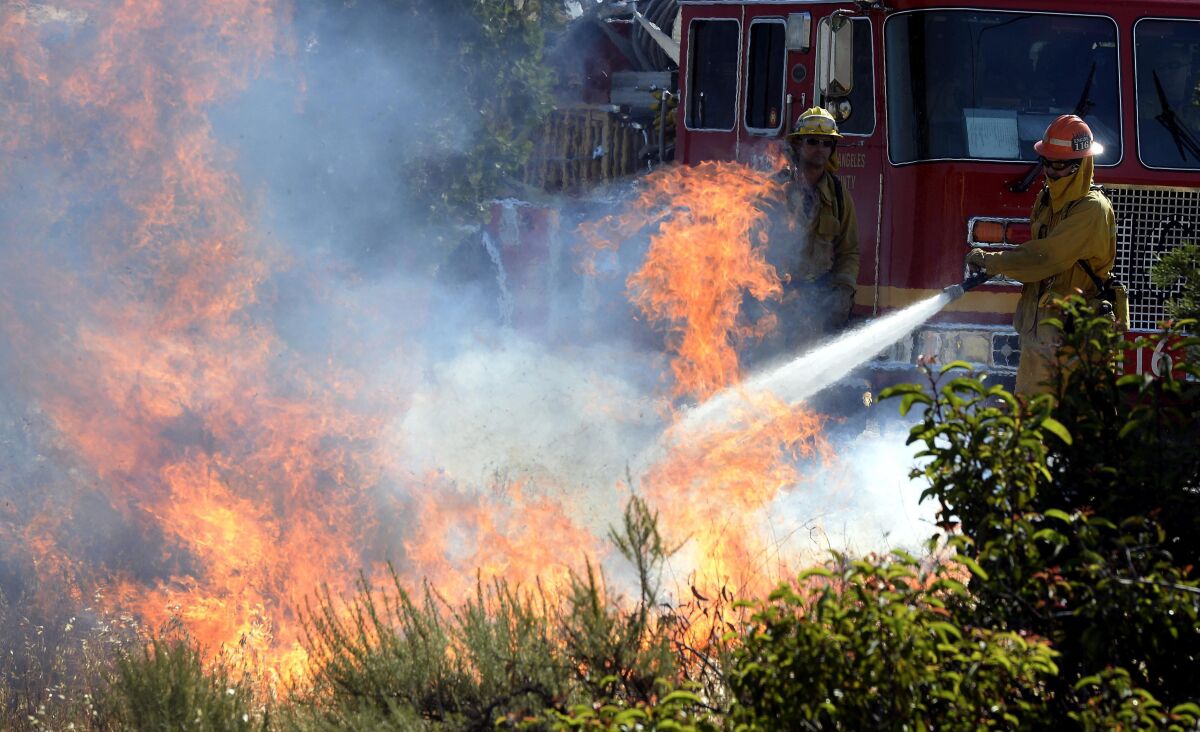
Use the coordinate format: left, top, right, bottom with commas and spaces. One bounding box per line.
768, 107, 859, 352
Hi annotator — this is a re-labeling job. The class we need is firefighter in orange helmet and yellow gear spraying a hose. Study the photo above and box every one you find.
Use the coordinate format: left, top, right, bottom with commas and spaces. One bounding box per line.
966, 114, 1117, 396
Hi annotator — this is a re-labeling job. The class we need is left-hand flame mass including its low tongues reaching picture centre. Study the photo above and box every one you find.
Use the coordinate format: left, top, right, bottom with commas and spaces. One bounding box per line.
0, 0, 619, 680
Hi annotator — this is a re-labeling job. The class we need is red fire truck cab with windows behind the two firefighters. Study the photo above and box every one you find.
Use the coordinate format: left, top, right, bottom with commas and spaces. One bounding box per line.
676, 0, 1200, 374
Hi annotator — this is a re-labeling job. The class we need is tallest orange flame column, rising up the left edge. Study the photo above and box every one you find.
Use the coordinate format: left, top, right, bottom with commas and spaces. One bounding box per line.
0, 0, 378, 676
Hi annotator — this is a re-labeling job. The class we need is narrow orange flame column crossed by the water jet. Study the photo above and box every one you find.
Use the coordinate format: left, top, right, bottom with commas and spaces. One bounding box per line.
583, 160, 833, 646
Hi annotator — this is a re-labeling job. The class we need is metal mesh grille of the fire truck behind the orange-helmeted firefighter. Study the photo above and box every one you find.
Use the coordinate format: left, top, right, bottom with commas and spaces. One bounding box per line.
1104, 184, 1200, 330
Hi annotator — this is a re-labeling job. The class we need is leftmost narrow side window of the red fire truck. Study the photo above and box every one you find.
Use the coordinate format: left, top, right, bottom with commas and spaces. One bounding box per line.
686, 20, 740, 130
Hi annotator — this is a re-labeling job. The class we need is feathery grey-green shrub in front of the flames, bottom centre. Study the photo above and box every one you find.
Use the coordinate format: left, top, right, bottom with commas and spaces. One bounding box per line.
292, 498, 705, 730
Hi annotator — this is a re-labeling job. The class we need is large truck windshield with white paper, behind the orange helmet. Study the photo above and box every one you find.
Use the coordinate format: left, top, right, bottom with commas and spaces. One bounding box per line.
884, 10, 1121, 166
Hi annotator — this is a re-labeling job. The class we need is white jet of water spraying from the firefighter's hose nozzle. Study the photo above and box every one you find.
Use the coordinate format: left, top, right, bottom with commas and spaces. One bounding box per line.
677, 286, 962, 437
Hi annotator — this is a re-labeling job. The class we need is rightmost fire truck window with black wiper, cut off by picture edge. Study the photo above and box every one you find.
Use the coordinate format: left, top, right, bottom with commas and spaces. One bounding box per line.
1134, 20, 1200, 170
